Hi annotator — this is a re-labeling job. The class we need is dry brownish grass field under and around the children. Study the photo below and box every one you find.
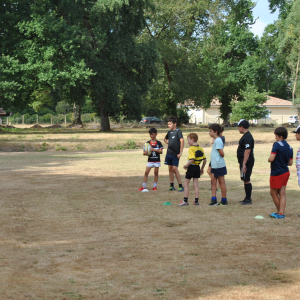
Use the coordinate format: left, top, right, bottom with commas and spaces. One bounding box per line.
0, 129, 300, 300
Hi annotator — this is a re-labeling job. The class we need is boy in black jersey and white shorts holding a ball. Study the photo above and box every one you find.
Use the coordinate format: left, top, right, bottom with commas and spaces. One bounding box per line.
138, 128, 164, 192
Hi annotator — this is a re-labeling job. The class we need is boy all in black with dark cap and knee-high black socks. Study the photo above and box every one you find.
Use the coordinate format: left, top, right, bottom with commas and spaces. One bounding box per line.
237, 119, 254, 205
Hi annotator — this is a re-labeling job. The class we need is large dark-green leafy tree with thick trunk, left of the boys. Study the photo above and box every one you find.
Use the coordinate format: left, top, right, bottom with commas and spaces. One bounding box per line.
1, 0, 156, 131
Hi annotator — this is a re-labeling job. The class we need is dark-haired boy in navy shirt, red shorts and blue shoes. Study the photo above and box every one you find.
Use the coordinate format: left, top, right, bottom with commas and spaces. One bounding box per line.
268, 127, 293, 219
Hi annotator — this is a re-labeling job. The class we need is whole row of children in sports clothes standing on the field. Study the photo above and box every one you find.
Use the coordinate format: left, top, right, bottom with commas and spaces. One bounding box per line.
139, 117, 300, 219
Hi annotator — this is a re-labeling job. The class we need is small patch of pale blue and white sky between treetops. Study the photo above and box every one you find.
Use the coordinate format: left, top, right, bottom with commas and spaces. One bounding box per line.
251, 0, 278, 37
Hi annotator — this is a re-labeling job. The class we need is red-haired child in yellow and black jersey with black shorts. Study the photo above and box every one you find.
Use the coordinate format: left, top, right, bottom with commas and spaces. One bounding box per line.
178, 133, 206, 206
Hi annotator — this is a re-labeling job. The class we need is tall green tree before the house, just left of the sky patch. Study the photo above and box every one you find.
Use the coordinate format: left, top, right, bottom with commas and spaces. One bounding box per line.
196, 0, 262, 123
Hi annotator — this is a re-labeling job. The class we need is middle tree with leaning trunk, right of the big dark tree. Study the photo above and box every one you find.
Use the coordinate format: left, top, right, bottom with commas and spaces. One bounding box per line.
142, 0, 221, 116
